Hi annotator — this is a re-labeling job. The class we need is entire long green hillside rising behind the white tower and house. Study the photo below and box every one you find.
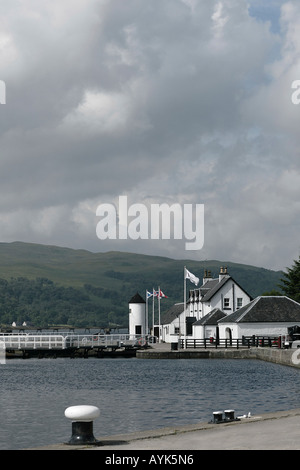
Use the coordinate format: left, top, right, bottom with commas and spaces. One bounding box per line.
0, 242, 283, 327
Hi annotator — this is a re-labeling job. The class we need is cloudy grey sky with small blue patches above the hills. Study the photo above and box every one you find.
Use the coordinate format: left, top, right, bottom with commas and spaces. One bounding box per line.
0, 0, 300, 270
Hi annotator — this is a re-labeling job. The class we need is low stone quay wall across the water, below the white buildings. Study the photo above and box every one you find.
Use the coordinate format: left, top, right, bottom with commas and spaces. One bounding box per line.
136, 347, 300, 368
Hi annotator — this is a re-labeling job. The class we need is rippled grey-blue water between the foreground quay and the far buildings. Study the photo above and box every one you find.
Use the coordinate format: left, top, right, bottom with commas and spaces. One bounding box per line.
0, 358, 300, 449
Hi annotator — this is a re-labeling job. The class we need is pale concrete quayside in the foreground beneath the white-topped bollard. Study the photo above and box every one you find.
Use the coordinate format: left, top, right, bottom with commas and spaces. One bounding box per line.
29, 409, 300, 455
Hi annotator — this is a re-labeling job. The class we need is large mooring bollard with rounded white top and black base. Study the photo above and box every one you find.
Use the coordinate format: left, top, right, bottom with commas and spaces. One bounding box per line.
65, 405, 101, 445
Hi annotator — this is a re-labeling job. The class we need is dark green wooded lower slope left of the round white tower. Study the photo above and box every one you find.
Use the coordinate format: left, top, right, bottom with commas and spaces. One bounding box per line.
0, 277, 128, 327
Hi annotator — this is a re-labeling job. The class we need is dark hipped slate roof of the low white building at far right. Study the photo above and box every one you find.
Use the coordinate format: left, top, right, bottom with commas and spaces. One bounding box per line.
218, 296, 300, 323
